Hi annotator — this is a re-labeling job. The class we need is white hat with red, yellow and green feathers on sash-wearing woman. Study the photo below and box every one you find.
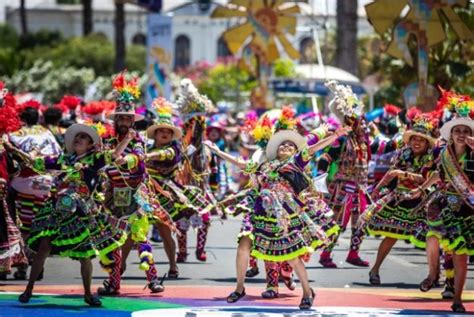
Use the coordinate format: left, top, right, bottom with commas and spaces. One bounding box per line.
437, 89, 474, 141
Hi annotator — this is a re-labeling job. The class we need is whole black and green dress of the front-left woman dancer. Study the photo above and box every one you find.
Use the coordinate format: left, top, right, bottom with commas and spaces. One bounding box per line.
28, 151, 127, 261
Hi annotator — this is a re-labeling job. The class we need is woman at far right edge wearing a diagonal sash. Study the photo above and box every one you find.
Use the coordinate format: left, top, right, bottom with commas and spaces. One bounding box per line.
412, 91, 474, 313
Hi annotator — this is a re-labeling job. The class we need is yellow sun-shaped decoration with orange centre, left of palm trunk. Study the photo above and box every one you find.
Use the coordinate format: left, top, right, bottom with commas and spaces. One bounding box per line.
211, 0, 300, 63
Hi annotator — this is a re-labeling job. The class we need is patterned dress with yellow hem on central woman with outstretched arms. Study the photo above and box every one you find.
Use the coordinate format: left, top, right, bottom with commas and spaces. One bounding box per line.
244, 150, 334, 262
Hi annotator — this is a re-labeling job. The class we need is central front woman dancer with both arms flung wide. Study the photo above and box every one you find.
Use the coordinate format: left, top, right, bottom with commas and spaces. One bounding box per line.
206, 109, 348, 309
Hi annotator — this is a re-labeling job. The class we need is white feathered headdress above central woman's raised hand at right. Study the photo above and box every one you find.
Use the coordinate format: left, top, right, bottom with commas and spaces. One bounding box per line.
325, 80, 364, 124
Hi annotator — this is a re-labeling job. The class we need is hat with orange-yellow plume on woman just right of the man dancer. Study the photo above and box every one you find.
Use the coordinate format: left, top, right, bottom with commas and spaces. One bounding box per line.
146, 97, 182, 140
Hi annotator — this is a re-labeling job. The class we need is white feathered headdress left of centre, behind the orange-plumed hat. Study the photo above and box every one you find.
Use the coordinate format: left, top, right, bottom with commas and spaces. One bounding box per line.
176, 78, 214, 122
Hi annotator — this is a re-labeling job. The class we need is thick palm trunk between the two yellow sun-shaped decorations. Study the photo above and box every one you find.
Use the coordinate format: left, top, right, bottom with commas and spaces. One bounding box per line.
336, 0, 358, 75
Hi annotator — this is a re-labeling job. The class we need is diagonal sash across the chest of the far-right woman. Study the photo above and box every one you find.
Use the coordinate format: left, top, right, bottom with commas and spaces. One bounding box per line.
441, 147, 474, 208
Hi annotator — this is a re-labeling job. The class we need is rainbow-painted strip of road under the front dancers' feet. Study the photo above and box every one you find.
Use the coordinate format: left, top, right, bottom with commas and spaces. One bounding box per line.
0, 285, 474, 317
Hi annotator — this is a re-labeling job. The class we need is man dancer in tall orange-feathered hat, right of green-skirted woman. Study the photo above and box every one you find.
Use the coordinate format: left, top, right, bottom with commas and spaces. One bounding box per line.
98, 73, 165, 295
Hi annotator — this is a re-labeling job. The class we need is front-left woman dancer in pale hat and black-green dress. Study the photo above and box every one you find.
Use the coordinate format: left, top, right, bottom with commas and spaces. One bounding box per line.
18, 124, 127, 306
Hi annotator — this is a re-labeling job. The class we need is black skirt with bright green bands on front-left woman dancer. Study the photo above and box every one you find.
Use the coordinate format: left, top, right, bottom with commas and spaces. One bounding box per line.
28, 193, 127, 259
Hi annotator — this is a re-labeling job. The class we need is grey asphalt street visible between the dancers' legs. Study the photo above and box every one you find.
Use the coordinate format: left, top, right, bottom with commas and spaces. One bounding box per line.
2, 218, 474, 290
